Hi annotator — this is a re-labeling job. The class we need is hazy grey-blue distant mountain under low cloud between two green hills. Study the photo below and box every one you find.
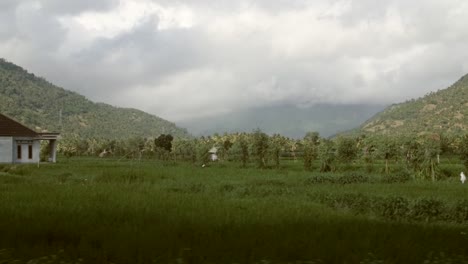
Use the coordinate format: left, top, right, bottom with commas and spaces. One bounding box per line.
178, 104, 385, 138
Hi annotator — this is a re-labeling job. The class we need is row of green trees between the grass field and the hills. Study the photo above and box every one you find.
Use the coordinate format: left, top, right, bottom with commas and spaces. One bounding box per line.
58, 129, 468, 180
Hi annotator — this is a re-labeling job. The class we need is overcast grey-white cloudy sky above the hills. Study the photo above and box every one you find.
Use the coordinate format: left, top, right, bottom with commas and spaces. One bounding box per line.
0, 0, 468, 121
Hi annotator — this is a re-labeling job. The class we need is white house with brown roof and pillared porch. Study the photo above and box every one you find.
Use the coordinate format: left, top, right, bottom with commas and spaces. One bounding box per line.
0, 114, 59, 163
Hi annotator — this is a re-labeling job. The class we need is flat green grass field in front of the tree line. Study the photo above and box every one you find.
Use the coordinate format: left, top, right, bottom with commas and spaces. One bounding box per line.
0, 158, 468, 263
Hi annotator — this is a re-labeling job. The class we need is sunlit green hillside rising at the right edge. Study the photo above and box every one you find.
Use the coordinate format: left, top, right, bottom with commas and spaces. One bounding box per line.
353, 75, 468, 134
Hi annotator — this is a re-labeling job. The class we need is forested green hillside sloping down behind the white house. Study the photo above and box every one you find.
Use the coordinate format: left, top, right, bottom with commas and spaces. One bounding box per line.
0, 59, 189, 139
